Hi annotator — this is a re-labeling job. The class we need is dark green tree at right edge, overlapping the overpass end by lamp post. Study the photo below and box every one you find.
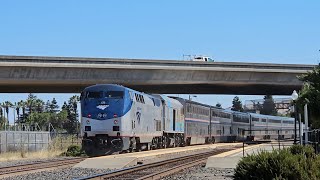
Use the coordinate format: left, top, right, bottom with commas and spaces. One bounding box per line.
297, 65, 320, 128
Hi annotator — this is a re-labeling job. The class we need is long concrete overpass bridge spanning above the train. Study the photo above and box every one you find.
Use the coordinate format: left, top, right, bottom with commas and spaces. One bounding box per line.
0, 56, 314, 95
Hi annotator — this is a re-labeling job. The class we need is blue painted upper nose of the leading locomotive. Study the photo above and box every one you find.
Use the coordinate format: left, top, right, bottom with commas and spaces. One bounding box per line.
81, 84, 133, 120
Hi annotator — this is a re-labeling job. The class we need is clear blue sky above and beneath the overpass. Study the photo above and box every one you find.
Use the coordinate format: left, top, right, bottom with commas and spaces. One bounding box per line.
0, 0, 320, 122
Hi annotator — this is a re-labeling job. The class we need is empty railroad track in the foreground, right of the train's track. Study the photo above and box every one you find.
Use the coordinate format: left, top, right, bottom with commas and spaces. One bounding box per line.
77, 148, 235, 180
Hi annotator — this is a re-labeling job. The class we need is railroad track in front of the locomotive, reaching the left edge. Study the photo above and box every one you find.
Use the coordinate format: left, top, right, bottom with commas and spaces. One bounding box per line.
0, 158, 86, 178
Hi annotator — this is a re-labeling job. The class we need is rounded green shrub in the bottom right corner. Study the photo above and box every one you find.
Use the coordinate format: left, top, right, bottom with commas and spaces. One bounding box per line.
234, 145, 320, 180
